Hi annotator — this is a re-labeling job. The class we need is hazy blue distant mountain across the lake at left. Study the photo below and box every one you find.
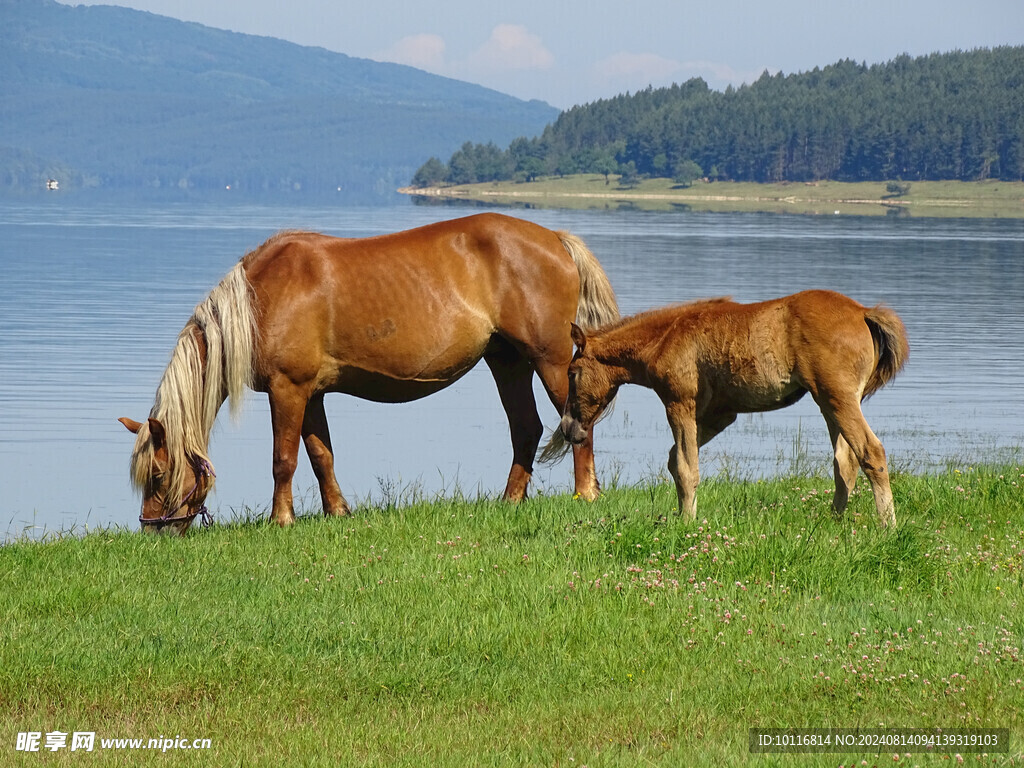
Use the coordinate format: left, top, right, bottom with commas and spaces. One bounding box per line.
0, 0, 558, 202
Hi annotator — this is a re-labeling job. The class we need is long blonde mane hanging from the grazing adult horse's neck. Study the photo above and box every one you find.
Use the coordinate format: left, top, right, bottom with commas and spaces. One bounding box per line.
130, 262, 256, 505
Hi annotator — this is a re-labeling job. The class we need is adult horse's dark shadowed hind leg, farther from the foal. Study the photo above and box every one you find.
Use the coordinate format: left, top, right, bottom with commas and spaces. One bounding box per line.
483, 346, 544, 502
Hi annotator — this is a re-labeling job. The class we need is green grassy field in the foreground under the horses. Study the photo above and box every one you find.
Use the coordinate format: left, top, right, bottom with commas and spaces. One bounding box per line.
0, 466, 1024, 768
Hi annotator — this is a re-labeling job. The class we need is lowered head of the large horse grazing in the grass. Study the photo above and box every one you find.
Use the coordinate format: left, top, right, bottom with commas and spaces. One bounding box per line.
118, 418, 214, 536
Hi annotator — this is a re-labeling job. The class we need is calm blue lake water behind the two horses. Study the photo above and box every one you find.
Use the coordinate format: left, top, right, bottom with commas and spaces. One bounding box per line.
0, 203, 1024, 537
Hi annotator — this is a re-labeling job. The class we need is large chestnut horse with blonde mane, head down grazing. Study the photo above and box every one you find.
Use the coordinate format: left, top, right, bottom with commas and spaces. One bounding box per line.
121, 213, 618, 534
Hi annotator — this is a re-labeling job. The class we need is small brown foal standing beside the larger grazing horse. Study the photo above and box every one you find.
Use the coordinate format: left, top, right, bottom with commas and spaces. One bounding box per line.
542, 291, 908, 526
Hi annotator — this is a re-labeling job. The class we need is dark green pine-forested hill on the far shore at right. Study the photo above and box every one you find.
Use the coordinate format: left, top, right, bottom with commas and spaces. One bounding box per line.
413, 46, 1024, 186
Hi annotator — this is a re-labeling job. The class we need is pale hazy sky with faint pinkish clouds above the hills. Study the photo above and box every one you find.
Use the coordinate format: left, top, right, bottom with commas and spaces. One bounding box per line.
58, 0, 1024, 109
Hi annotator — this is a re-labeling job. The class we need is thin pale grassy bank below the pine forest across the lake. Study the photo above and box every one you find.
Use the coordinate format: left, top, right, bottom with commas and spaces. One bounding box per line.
401, 175, 1024, 218
